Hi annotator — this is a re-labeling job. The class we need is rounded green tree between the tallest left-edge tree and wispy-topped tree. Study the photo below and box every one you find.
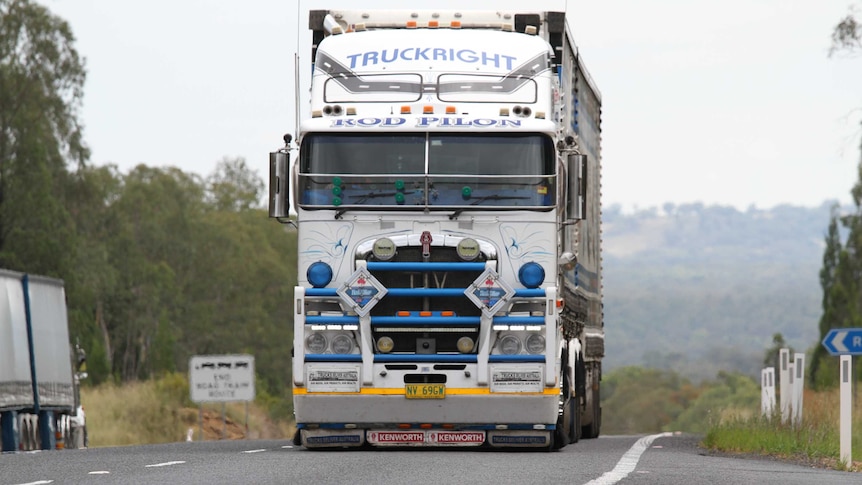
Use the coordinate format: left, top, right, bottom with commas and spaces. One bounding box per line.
99, 165, 207, 381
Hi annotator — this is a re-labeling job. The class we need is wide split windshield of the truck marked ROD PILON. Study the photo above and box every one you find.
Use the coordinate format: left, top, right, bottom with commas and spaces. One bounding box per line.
299, 133, 556, 210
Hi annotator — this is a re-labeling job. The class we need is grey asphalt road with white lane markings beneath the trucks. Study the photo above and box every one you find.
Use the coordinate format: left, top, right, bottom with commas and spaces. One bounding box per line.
0, 435, 862, 485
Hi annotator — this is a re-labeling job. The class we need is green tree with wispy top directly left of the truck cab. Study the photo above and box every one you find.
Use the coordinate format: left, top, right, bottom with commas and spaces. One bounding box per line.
181, 158, 296, 398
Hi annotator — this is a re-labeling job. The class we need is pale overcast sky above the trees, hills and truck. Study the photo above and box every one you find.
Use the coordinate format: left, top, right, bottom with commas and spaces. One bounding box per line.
41, 0, 862, 209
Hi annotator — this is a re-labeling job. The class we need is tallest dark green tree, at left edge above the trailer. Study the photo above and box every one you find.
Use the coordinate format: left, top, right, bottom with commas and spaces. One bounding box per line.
0, 0, 89, 277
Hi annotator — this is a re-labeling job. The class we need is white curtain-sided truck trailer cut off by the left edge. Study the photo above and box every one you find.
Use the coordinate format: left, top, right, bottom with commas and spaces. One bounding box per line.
0, 269, 86, 452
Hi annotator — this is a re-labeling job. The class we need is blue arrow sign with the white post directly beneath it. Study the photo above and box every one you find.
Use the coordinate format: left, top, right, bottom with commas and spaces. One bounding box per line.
823, 328, 862, 466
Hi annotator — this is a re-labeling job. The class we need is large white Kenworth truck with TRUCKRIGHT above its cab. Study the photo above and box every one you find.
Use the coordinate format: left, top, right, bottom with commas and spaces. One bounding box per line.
270, 10, 604, 450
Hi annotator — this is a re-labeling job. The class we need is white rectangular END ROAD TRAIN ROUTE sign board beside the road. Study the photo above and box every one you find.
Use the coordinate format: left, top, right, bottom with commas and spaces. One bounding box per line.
189, 355, 254, 403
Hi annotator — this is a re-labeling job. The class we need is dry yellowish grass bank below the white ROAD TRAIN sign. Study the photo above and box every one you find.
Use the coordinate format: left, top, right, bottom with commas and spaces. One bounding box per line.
81, 374, 293, 447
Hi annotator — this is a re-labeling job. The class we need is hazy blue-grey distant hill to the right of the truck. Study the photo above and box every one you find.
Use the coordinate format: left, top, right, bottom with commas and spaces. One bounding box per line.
603, 202, 833, 378
